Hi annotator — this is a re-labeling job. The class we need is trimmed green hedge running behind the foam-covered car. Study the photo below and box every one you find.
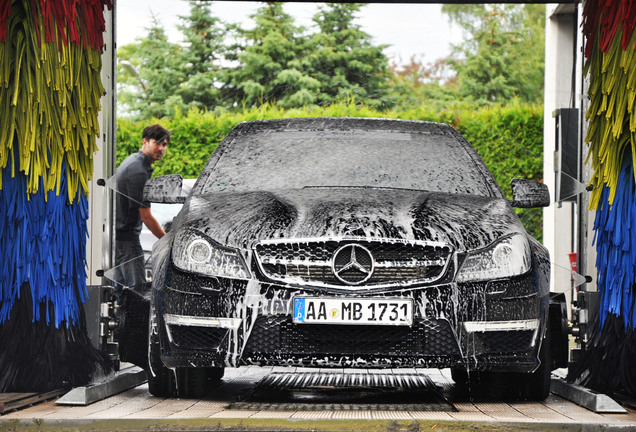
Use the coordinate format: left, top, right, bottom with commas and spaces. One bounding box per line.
117, 103, 543, 240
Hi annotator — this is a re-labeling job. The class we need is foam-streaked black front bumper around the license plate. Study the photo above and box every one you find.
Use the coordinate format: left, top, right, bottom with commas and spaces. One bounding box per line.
153, 268, 547, 372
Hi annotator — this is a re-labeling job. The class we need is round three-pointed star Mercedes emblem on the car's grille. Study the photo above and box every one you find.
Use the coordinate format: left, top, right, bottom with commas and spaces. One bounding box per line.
331, 243, 375, 285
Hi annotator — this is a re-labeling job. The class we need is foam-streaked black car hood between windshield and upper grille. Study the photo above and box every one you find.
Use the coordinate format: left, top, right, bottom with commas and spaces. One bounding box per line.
175, 188, 525, 251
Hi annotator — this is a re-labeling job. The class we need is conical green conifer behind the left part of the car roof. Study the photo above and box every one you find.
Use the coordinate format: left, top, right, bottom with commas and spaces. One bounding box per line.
228, 3, 320, 108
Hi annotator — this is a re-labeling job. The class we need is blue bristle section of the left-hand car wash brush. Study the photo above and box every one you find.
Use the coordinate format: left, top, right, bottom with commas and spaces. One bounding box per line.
0, 157, 88, 328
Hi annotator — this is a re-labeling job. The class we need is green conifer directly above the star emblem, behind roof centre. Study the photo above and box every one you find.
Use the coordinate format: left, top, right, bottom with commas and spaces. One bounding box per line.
307, 3, 390, 108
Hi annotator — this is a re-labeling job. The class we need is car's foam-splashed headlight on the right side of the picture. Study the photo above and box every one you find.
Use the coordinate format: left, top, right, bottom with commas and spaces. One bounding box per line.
456, 234, 530, 282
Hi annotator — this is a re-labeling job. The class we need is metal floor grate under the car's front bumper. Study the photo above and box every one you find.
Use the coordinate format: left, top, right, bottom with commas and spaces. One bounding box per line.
228, 372, 456, 411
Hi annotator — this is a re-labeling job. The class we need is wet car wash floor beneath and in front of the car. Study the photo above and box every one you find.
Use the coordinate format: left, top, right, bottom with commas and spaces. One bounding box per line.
0, 367, 636, 432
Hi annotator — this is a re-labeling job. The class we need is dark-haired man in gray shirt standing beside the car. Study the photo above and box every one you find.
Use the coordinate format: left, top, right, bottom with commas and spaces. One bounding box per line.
115, 124, 170, 294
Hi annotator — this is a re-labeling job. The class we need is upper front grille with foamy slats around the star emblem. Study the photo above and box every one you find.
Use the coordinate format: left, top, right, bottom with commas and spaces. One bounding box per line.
255, 239, 452, 289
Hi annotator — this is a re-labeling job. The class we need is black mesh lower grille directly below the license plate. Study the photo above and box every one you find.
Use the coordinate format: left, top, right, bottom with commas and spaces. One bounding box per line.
244, 316, 460, 357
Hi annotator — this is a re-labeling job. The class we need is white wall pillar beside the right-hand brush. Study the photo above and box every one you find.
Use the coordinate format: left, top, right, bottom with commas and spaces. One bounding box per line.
543, 4, 596, 308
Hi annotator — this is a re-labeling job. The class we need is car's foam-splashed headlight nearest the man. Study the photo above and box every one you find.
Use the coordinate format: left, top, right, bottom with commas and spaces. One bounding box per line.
172, 230, 250, 279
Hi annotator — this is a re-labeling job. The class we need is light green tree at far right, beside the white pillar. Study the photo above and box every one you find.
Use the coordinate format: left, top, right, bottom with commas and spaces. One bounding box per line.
442, 4, 545, 103
